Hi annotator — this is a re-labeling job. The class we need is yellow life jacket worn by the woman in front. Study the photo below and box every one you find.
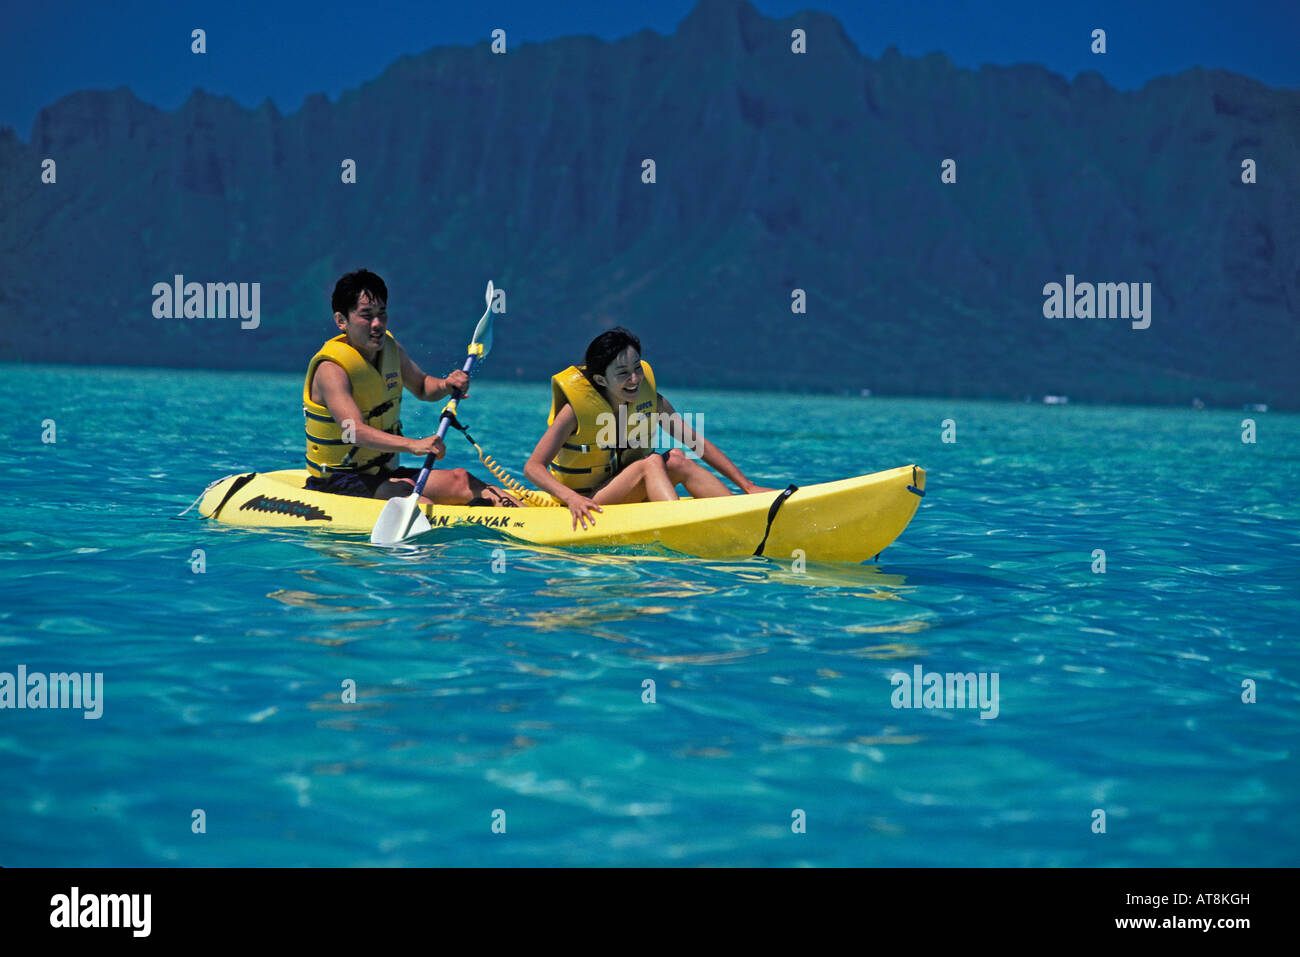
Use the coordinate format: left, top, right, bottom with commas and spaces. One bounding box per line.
546, 359, 658, 492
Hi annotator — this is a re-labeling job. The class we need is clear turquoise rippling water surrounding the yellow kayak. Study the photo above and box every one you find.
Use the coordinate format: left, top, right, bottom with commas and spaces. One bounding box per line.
0, 365, 1300, 866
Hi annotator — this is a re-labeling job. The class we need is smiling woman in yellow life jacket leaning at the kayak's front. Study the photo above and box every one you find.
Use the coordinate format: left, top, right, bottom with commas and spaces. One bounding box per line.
524, 326, 771, 529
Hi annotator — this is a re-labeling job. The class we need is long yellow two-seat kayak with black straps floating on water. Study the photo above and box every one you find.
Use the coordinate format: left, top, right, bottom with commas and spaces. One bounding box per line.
199, 465, 926, 562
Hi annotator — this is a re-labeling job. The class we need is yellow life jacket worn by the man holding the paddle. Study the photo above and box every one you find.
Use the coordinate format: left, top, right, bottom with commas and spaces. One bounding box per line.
303, 332, 402, 479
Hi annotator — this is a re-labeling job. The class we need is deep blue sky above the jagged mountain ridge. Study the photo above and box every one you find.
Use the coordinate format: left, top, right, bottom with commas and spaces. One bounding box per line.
0, 0, 1300, 139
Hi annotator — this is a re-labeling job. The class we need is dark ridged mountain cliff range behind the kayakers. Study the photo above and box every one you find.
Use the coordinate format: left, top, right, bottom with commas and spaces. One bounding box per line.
0, 0, 1300, 407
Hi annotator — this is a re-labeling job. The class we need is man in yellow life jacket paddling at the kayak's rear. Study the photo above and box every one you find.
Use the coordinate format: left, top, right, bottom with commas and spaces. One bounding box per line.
303, 269, 519, 505
